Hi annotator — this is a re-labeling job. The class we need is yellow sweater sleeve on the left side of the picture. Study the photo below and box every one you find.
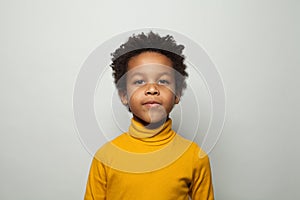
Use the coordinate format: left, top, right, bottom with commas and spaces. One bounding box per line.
84, 158, 107, 200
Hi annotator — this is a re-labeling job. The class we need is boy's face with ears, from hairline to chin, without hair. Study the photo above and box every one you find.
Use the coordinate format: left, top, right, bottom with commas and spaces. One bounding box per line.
120, 52, 179, 124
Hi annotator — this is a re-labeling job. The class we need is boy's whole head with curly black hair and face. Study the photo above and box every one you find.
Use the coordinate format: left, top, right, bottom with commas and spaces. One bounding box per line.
111, 32, 188, 124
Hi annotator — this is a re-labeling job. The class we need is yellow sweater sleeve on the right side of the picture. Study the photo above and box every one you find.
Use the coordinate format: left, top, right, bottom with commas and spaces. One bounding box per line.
190, 149, 214, 200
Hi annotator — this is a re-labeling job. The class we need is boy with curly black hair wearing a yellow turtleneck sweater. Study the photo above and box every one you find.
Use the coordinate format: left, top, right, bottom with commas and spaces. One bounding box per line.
85, 32, 214, 200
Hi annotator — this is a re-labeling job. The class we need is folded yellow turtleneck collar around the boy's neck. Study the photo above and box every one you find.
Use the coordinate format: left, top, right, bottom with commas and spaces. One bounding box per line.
128, 119, 176, 145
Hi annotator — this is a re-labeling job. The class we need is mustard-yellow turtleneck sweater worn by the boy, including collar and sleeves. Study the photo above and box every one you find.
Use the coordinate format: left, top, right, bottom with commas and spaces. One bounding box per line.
84, 119, 214, 200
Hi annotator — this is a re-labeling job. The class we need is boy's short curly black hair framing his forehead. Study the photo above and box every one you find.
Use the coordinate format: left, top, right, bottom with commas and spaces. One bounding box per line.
110, 31, 188, 95
